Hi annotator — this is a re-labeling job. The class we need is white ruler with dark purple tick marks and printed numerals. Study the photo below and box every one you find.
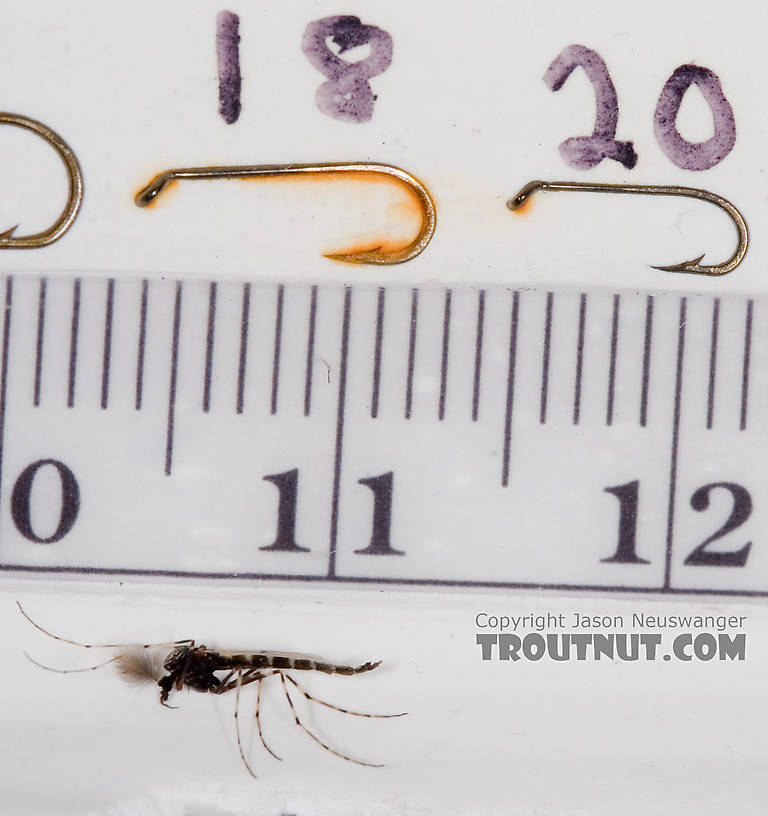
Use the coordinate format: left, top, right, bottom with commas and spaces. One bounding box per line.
0, 276, 768, 596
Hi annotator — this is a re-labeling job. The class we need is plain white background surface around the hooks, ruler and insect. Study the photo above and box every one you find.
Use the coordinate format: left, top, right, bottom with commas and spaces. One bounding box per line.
0, 2, 768, 816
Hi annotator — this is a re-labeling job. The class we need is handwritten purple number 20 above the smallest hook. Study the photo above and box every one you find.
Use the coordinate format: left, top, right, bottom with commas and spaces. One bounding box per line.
544, 45, 736, 170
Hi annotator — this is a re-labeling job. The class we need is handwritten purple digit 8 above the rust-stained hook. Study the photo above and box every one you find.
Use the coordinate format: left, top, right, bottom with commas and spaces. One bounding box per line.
301, 15, 392, 122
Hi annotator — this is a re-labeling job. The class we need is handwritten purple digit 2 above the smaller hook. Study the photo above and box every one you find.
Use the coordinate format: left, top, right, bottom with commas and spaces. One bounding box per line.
544, 45, 637, 170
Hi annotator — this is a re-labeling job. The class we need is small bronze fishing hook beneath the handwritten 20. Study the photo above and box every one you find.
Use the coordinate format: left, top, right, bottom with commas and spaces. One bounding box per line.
507, 181, 749, 275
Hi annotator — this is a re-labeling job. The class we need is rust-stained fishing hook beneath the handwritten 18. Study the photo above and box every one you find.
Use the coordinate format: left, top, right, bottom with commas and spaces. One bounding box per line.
135, 162, 437, 264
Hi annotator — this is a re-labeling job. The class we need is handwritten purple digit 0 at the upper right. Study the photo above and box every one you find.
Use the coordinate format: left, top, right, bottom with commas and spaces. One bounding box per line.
653, 65, 736, 170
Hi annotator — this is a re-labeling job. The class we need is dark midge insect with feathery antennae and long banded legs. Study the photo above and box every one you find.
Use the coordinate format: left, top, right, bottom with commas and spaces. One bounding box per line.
16, 601, 407, 779
